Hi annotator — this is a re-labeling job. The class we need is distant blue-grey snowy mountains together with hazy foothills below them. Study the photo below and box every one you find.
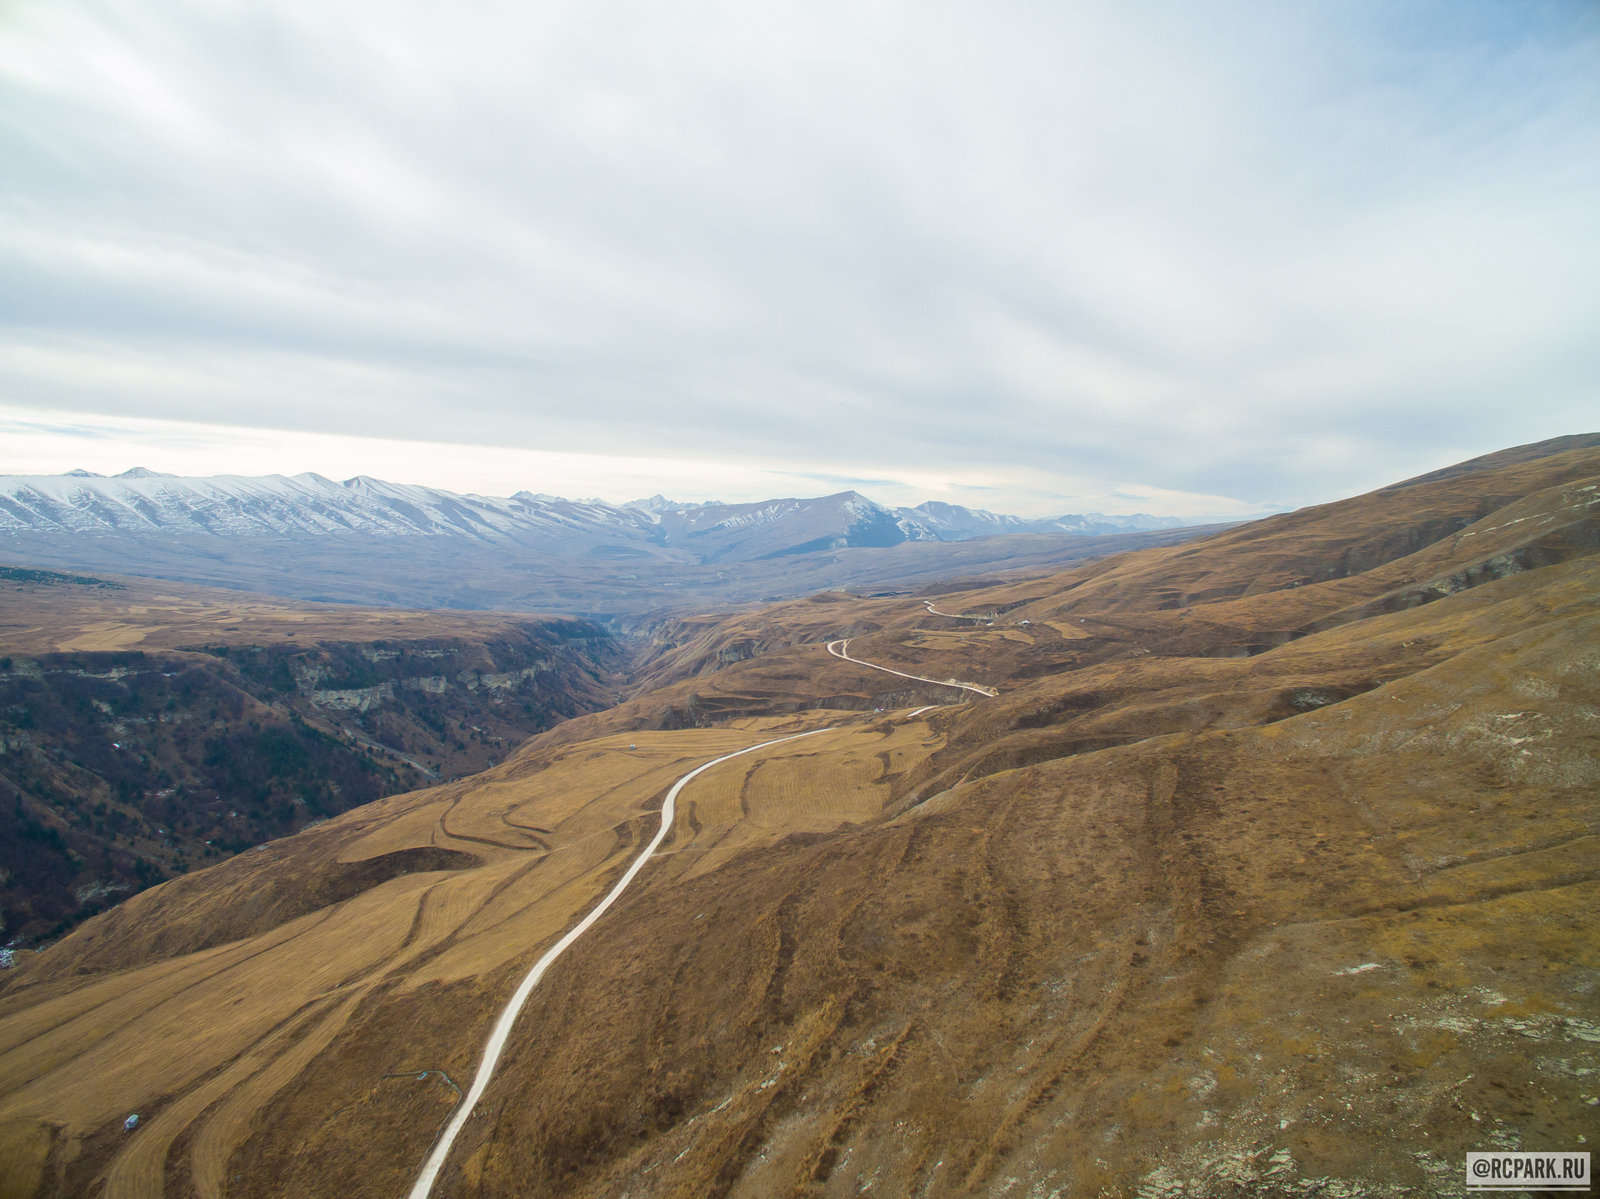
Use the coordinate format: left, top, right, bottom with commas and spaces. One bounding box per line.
0, 467, 1222, 613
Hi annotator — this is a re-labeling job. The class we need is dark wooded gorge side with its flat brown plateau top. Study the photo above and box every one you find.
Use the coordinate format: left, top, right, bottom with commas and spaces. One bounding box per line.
0, 568, 619, 946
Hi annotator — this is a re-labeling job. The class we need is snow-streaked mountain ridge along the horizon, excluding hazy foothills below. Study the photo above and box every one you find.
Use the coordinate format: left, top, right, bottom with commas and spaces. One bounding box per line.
0, 467, 1184, 565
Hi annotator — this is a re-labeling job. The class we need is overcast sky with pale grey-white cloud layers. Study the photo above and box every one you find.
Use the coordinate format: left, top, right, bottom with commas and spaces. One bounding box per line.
0, 0, 1600, 515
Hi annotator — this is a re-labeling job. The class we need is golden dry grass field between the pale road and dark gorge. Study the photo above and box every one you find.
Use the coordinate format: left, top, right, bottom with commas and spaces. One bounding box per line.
0, 716, 926, 1196
